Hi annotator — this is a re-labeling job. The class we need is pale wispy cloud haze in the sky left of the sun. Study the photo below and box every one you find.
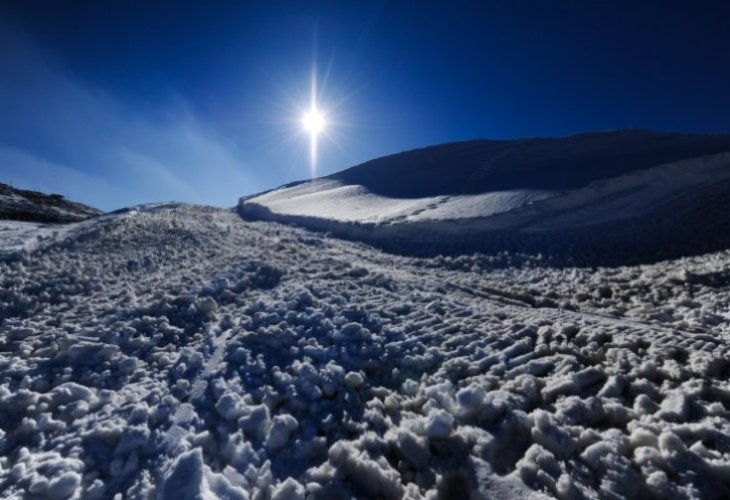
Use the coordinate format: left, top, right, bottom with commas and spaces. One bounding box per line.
0, 30, 263, 209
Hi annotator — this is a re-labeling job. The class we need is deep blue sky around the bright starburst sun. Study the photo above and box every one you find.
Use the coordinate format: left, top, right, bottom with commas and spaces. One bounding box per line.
0, 0, 730, 210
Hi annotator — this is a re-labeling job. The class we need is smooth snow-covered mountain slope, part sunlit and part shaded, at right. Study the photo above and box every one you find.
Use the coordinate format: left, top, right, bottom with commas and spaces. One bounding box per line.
239, 131, 730, 263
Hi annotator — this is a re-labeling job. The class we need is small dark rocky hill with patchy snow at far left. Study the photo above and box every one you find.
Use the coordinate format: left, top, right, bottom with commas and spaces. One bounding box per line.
0, 183, 101, 222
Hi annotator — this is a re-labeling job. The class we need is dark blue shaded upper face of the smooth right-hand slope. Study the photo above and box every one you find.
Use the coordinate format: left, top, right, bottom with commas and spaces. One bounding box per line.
328, 130, 730, 198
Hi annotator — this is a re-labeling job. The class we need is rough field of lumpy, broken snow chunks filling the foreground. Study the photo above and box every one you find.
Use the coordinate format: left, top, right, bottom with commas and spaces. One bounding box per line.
0, 205, 730, 500
